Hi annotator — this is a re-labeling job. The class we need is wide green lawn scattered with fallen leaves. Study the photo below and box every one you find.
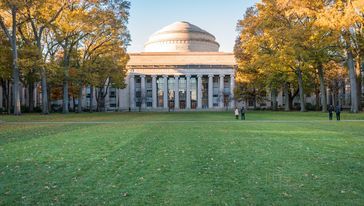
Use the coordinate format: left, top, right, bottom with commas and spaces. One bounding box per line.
0, 112, 364, 205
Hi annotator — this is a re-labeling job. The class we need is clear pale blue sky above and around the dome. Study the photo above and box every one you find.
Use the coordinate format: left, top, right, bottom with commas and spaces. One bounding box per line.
128, 0, 259, 52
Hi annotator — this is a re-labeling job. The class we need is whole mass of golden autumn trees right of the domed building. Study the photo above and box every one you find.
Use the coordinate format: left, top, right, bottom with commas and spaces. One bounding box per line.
235, 0, 364, 112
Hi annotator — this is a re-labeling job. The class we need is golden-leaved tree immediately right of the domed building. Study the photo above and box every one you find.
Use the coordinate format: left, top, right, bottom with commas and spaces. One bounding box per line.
235, 0, 311, 111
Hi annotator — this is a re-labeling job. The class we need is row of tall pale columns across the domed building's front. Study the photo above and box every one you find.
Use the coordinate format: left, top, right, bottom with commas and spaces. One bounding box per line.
129, 72, 235, 111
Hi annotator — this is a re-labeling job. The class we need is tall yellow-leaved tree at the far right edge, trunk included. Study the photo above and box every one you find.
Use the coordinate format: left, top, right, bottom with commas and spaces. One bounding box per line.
319, 0, 364, 113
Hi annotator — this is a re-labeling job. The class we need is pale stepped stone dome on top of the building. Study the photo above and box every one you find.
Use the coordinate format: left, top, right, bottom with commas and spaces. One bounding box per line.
144, 21, 220, 52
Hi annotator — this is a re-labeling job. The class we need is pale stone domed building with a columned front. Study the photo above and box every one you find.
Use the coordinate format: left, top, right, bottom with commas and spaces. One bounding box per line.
119, 22, 236, 111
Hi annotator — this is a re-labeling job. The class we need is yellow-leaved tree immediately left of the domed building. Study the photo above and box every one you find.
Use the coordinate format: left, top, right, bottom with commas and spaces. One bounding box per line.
75, 1, 129, 112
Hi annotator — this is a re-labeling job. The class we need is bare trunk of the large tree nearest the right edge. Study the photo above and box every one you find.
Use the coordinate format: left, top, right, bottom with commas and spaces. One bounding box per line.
347, 49, 359, 113
